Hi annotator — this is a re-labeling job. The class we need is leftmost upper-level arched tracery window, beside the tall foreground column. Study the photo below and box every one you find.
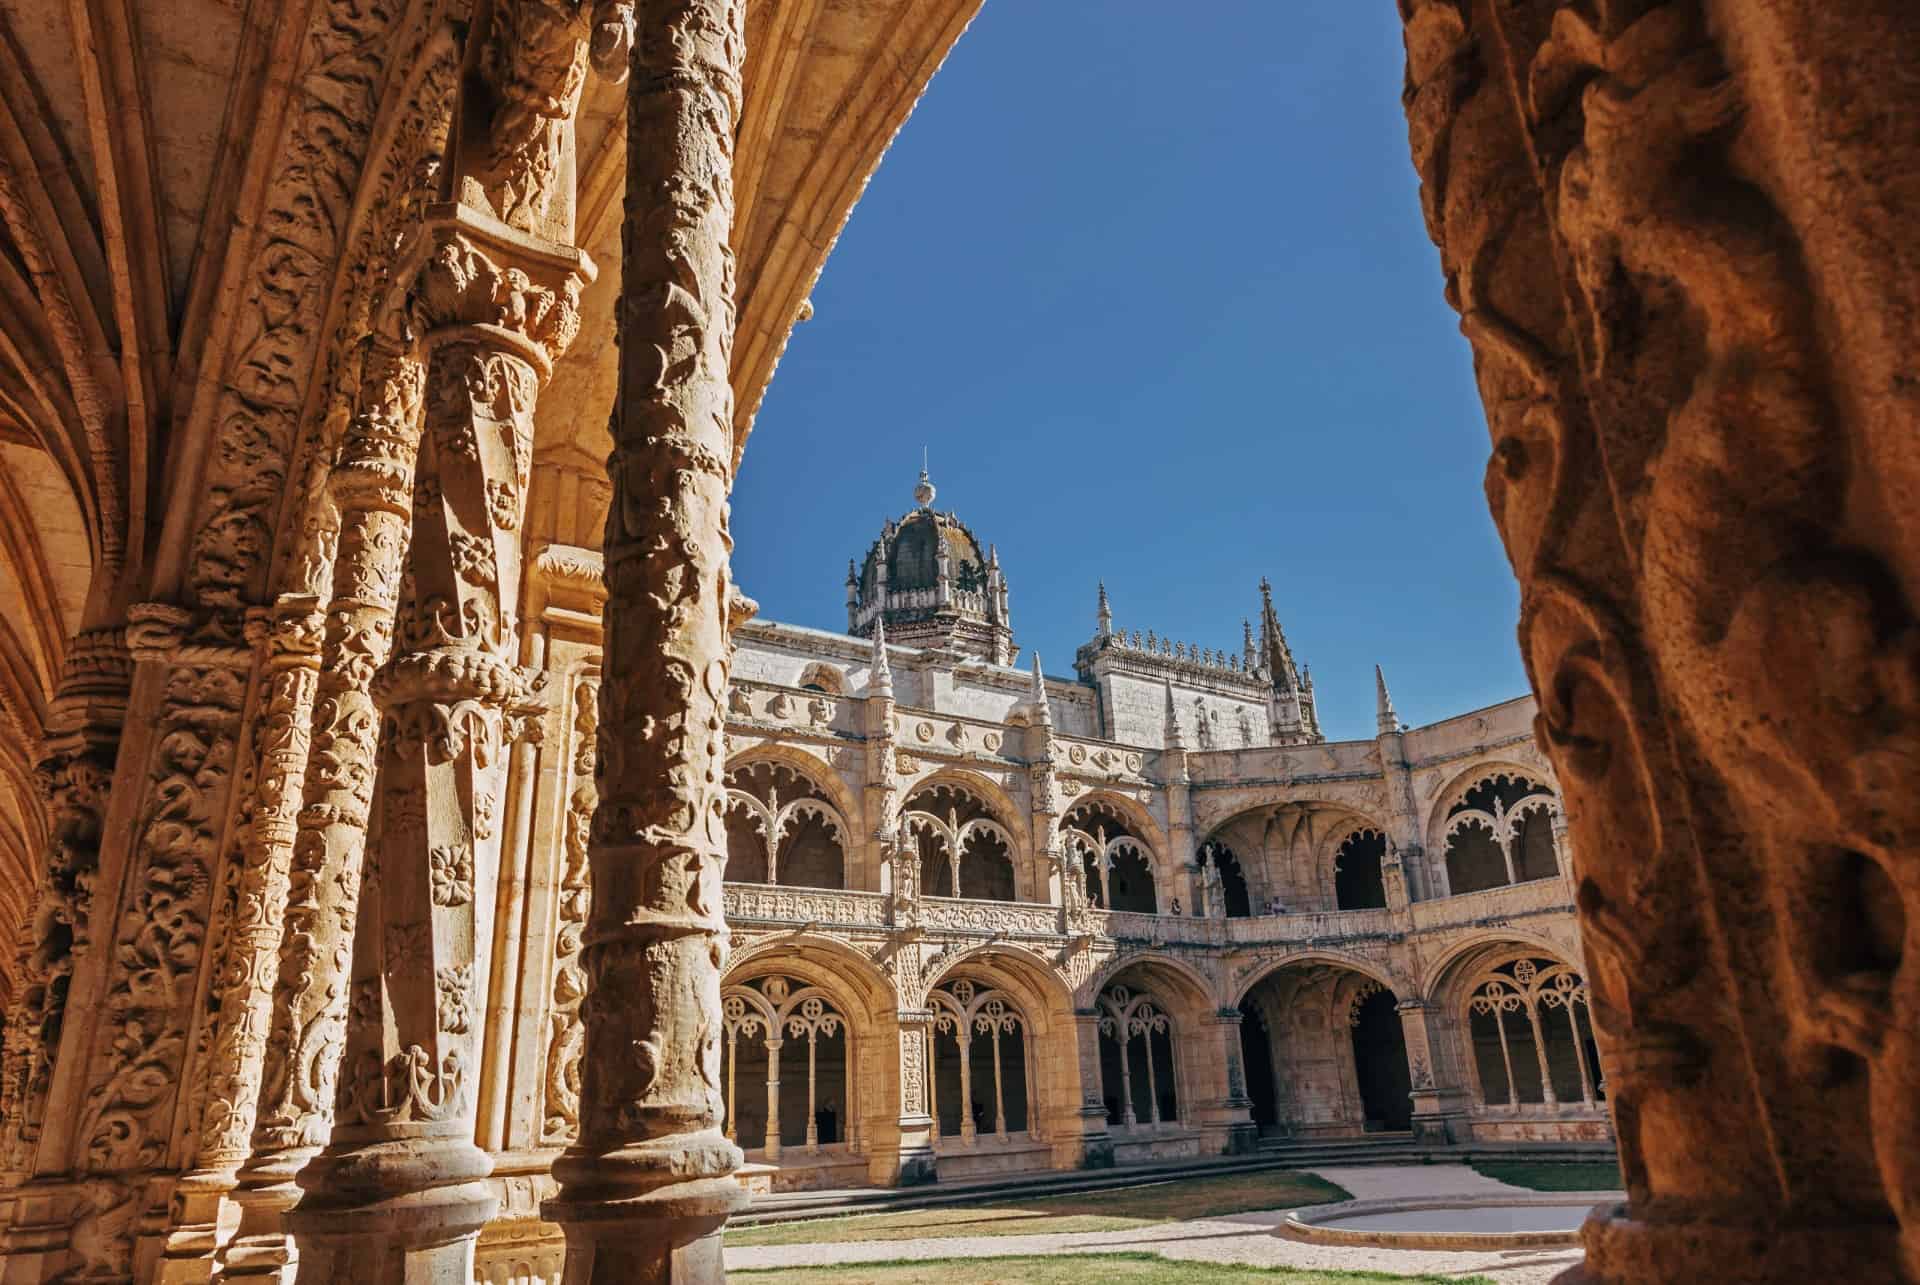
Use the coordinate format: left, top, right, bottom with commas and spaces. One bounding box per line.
726, 759, 852, 887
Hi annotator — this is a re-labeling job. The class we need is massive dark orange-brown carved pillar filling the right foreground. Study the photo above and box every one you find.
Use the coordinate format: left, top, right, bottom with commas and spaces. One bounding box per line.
1402, 0, 1920, 1283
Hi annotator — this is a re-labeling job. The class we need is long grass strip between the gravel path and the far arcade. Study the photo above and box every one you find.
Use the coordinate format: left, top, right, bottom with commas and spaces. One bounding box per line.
726, 1170, 1352, 1244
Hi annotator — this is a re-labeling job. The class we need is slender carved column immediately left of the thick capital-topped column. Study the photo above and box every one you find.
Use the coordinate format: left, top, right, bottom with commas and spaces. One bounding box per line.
225, 317, 426, 1279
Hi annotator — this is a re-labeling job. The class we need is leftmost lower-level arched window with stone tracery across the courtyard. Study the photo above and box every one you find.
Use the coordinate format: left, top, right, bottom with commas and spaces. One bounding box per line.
720, 978, 856, 1160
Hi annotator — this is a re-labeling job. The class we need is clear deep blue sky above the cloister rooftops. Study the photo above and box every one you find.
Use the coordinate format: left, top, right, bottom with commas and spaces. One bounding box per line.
733, 0, 1526, 739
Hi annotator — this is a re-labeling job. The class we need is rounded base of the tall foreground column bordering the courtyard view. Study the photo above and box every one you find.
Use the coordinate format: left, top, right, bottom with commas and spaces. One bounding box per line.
540, 1129, 747, 1285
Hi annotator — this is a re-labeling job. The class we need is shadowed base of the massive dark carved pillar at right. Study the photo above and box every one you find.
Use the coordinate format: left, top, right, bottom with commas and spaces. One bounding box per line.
1553, 1204, 1907, 1285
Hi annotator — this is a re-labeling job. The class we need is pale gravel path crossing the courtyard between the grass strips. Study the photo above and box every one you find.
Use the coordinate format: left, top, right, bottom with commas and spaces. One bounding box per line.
726, 1164, 1580, 1285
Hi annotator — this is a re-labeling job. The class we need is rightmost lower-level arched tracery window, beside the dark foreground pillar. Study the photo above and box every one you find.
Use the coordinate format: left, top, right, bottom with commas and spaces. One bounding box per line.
1467, 957, 1603, 1108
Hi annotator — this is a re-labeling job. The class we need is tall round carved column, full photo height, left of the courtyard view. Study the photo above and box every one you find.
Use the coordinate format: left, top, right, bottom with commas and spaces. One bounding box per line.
545, 0, 745, 1285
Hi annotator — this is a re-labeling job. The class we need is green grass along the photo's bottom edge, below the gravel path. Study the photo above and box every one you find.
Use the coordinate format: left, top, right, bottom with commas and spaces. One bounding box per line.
728, 1254, 1494, 1285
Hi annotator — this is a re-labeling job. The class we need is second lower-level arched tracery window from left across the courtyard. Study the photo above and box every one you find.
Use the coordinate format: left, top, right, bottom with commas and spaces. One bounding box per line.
927, 978, 1035, 1147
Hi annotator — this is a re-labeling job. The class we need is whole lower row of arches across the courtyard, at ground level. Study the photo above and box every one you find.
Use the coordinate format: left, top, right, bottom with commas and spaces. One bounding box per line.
720, 932, 1609, 1193
